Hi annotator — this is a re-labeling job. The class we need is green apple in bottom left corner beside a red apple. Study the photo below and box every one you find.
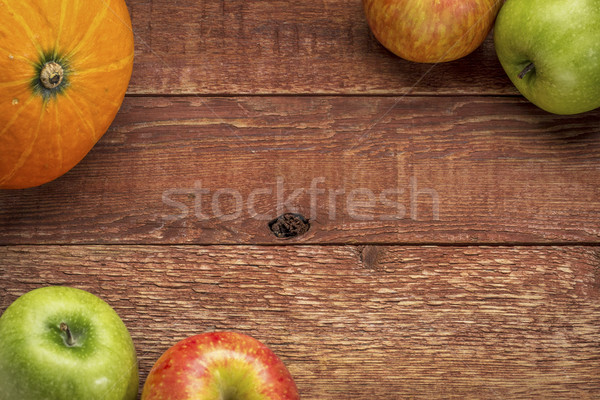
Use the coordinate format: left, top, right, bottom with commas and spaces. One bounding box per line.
0, 286, 139, 400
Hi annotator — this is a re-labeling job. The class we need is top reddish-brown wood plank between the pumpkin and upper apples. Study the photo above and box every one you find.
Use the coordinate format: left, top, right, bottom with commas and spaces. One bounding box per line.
127, 0, 510, 95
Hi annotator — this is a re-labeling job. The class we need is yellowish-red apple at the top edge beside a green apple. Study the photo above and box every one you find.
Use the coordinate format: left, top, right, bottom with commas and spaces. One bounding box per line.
363, 0, 504, 63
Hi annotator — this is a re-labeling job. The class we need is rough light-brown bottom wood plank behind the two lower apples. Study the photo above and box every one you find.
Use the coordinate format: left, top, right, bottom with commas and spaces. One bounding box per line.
0, 246, 600, 400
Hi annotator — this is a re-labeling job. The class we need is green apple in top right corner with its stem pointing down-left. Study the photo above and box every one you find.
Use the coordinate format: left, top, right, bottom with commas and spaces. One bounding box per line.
494, 0, 600, 114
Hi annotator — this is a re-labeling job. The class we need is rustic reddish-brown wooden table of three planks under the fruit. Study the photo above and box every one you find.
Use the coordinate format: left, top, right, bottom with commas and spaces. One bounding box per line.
0, 0, 600, 400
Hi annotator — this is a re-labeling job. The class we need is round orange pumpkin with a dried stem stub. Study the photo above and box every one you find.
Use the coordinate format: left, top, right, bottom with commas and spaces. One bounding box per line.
0, 0, 133, 189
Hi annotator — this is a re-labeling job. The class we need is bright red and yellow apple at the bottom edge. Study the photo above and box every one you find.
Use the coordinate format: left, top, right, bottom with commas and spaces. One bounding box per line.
142, 332, 300, 400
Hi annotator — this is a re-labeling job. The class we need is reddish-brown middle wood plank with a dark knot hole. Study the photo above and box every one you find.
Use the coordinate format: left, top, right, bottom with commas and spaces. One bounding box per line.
0, 97, 600, 244
